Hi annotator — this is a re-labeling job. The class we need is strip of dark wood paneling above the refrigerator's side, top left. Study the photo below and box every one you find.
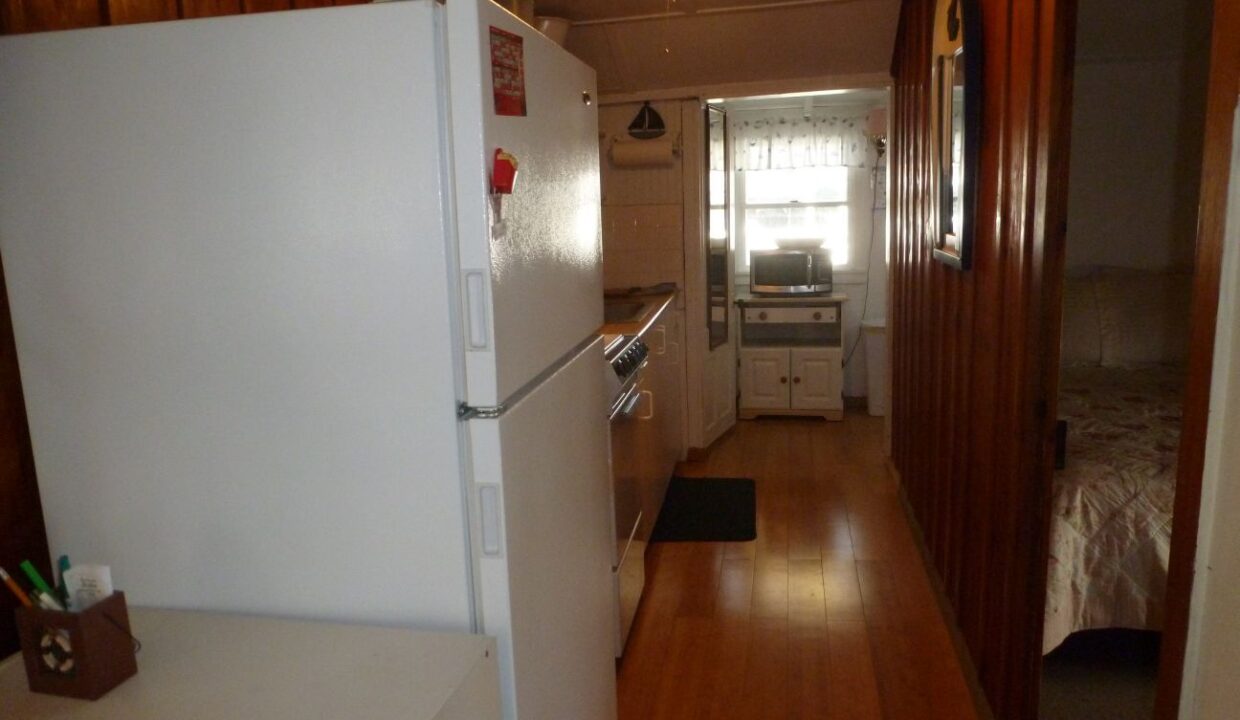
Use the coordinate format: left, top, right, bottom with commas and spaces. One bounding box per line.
0, 0, 367, 35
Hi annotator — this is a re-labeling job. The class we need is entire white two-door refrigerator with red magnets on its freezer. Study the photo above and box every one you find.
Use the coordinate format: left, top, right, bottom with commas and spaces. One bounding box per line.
0, 0, 615, 720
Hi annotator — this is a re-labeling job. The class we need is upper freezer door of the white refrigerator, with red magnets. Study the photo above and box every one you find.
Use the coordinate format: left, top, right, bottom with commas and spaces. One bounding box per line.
448, 0, 603, 406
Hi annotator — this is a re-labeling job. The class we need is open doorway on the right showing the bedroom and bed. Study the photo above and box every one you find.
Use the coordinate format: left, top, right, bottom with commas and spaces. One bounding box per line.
1040, 0, 1211, 720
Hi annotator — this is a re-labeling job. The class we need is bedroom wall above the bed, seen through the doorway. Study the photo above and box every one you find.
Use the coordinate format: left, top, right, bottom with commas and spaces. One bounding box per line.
1066, 0, 1209, 269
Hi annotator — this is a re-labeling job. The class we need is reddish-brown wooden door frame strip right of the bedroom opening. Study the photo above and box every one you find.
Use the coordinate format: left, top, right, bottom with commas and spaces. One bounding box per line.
1154, 0, 1240, 720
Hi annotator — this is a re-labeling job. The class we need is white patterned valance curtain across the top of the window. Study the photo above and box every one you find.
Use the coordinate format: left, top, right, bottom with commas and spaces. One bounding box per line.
729, 108, 869, 170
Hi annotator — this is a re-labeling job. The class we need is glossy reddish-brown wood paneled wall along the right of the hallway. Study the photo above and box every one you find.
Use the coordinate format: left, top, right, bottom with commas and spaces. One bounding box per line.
889, 0, 1075, 720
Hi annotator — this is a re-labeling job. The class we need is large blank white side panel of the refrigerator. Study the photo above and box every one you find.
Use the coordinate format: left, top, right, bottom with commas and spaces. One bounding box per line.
0, 2, 472, 622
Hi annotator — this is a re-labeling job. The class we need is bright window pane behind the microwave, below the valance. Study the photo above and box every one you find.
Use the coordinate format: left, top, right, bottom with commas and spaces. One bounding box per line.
735, 166, 857, 271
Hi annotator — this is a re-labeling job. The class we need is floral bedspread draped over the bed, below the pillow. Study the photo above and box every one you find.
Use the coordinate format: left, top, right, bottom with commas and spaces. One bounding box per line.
1043, 366, 1183, 653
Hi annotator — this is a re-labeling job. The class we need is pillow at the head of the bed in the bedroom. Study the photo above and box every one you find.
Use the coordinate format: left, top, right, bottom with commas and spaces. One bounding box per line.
1097, 268, 1193, 367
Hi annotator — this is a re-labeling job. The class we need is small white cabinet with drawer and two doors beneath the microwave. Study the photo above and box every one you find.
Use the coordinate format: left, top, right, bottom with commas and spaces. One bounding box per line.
738, 296, 844, 420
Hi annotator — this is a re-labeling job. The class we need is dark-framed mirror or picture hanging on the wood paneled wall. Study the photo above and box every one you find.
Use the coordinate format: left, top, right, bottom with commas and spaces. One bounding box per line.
930, 0, 982, 270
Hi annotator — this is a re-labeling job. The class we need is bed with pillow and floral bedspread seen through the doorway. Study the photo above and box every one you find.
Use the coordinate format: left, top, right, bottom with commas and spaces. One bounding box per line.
1043, 269, 1190, 653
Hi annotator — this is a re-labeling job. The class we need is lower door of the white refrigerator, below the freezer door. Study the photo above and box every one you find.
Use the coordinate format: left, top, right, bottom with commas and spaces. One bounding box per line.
469, 340, 616, 720
